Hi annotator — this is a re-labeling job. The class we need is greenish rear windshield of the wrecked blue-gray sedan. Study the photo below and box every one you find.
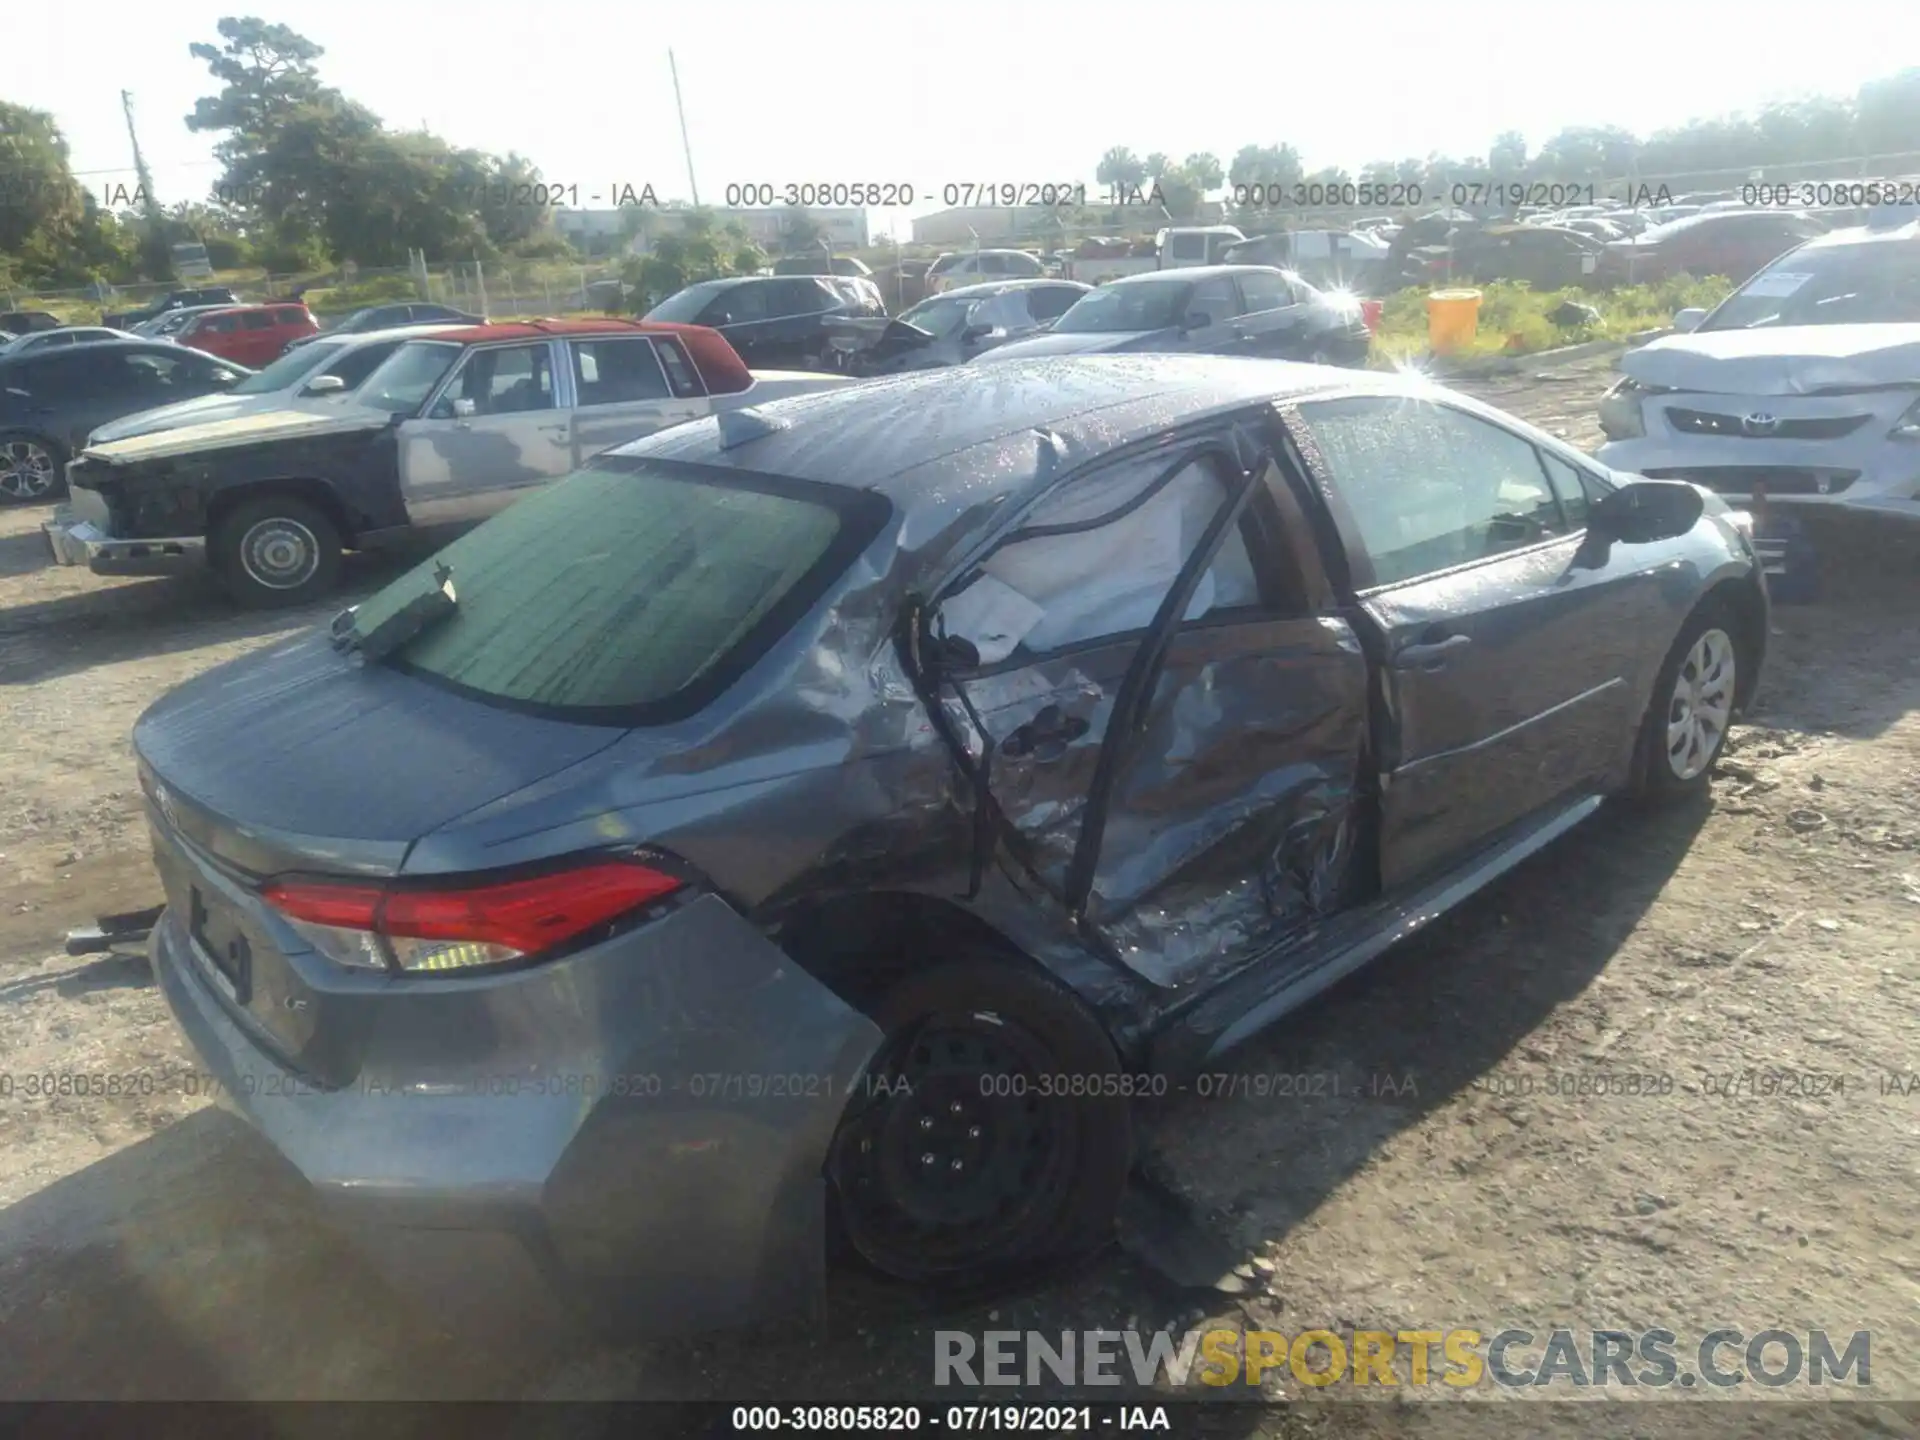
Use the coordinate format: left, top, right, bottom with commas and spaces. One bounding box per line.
355, 455, 889, 724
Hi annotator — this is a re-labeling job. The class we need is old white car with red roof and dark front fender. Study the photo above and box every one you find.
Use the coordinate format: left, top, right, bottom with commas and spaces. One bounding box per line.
44, 321, 852, 609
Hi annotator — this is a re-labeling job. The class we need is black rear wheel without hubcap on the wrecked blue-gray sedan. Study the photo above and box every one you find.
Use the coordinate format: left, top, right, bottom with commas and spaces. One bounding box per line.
828, 956, 1131, 1283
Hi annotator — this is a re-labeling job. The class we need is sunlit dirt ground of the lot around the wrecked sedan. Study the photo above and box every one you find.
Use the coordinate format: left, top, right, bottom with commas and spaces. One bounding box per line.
0, 361, 1920, 1434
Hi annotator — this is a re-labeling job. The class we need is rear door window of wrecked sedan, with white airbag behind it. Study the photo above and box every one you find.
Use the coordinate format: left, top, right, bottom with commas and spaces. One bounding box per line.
941, 459, 1260, 664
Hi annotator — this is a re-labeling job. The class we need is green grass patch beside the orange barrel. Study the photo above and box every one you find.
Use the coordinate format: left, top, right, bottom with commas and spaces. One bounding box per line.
1373, 275, 1734, 363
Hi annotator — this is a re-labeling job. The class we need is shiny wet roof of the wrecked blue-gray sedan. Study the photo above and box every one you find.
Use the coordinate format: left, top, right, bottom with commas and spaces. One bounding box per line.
629, 355, 1417, 511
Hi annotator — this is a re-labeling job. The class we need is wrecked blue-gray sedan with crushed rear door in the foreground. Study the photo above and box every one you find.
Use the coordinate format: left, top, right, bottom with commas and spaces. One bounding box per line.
134, 355, 1768, 1329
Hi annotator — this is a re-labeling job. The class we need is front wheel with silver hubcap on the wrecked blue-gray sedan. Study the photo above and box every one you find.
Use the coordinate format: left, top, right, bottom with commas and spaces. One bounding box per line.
1640, 601, 1741, 803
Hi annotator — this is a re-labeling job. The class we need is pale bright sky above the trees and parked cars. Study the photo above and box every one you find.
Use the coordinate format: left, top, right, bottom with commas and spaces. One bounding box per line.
0, 0, 1920, 240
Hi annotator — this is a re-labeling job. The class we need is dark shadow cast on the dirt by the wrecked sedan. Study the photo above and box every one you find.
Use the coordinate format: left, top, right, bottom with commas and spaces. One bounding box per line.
0, 806, 1709, 1438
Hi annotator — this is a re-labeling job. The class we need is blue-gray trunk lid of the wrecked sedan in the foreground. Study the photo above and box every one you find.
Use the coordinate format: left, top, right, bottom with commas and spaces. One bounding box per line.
132, 632, 645, 1085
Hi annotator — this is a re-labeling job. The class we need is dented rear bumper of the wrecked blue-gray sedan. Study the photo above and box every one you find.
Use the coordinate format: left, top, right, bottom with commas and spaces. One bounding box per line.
150, 897, 881, 1334
